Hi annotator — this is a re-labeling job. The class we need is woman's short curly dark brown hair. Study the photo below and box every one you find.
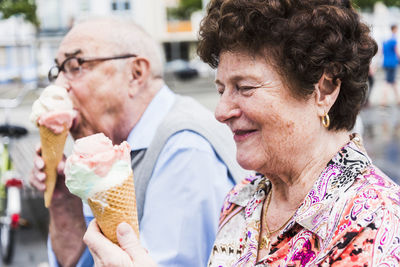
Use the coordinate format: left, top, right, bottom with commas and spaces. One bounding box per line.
198, 0, 377, 130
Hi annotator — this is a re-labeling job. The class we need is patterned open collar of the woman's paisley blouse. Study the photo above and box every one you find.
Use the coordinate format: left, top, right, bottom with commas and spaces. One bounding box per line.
229, 134, 371, 242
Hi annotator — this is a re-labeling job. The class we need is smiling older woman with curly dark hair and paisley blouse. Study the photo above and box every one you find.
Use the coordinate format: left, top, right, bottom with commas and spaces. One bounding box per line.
85, 0, 400, 266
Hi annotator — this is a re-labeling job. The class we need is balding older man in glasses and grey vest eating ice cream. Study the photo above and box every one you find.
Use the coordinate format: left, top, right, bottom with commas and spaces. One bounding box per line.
31, 18, 243, 267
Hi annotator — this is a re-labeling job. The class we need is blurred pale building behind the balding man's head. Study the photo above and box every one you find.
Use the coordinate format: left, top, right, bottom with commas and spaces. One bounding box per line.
0, 0, 216, 83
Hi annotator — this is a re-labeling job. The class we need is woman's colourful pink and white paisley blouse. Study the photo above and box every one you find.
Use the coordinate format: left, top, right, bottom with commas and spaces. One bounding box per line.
209, 135, 400, 267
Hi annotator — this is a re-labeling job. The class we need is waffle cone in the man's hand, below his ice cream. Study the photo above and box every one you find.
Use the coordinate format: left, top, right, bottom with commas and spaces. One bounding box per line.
39, 126, 68, 208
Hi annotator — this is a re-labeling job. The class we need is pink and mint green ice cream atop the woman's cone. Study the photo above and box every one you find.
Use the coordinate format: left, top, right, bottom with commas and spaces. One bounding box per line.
64, 133, 132, 201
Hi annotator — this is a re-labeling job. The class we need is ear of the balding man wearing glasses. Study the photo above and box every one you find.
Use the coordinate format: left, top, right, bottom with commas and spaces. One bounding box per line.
129, 57, 150, 94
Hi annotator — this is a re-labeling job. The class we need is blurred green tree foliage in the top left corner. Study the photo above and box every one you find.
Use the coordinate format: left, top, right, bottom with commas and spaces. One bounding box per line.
0, 0, 40, 28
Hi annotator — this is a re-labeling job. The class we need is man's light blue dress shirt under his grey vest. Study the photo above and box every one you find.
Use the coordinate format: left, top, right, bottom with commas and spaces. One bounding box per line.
49, 86, 234, 267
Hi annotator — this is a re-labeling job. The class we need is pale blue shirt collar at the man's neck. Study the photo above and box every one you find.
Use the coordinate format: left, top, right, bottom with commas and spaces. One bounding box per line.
127, 85, 176, 151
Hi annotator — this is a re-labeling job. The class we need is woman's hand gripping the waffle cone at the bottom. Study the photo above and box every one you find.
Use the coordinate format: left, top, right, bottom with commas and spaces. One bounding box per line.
83, 220, 157, 267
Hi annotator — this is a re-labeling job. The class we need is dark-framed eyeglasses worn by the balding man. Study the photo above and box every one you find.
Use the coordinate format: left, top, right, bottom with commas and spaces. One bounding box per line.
48, 54, 137, 82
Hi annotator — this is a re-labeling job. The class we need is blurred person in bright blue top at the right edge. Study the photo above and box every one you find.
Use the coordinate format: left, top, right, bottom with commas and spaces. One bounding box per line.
382, 25, 400, 105
